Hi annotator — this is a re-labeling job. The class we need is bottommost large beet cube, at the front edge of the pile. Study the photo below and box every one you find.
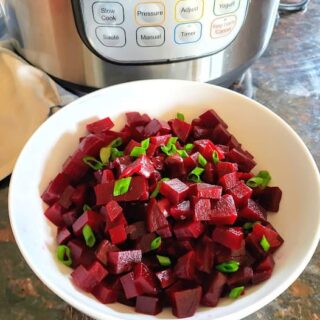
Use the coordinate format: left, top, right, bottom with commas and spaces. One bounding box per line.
170, 286, 202, 318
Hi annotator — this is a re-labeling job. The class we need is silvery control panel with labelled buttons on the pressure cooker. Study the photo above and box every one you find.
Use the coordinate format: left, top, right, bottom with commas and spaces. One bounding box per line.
74, 0, 249, 64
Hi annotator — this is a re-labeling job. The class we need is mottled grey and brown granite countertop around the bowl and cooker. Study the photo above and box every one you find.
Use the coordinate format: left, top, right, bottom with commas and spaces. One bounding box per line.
0, 1, 320, 320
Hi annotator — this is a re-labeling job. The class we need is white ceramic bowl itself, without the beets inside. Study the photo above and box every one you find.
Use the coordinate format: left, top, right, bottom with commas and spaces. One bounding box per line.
9, 80, 320, 320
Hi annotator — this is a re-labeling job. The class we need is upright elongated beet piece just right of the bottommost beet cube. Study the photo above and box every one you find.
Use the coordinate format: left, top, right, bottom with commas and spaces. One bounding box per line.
201, 272, 227, 307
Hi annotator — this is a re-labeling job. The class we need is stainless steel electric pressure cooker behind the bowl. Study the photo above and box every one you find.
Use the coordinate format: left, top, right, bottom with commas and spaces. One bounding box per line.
0, 0, 279, 88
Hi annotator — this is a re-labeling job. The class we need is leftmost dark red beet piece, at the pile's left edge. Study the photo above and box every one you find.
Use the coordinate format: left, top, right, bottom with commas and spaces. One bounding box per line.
41, 173, 70, 205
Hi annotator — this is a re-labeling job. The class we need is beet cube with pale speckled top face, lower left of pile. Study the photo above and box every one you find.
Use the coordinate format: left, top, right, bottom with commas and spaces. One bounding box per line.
108, 250, 142, 274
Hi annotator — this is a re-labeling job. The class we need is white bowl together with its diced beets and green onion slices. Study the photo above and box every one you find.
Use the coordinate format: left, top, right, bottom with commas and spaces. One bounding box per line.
9, 80, 320, 319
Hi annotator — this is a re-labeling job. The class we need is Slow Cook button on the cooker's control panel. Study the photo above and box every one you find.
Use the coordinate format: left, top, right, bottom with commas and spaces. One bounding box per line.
92, 2, 124, 25
